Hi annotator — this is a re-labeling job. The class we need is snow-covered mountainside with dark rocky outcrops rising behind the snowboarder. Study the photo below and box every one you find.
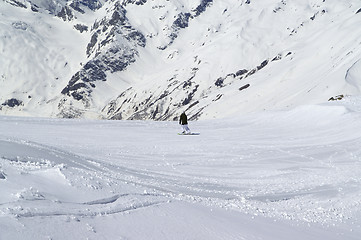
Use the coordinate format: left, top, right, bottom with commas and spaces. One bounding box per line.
0, 0, 361, 120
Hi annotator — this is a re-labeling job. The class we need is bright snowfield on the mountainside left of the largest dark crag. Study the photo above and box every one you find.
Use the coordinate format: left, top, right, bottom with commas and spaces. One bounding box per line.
0, 1, 87, 116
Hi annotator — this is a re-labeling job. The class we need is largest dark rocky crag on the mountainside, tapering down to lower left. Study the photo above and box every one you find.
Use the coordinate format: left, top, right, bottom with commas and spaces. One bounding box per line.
61, 2, 146, 114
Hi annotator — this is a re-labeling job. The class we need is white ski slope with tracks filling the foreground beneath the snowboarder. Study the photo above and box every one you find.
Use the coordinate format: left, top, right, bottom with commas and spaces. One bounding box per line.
0, 97, 361, 240
